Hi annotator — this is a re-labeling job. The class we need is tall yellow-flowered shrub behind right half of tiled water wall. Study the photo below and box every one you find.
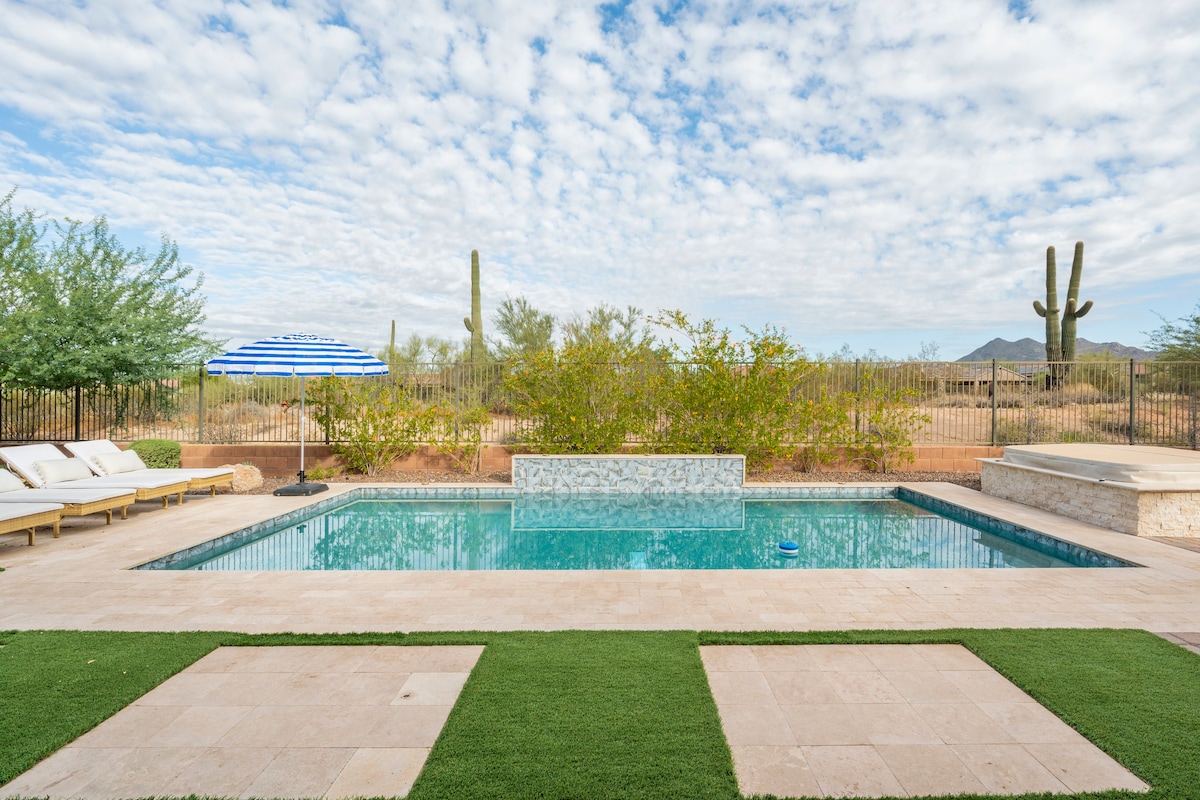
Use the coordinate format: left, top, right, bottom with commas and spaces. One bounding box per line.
650, 311, 816, 468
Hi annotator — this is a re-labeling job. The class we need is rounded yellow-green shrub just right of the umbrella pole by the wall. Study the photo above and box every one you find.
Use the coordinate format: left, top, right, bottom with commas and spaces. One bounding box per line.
312, 377, 434, 475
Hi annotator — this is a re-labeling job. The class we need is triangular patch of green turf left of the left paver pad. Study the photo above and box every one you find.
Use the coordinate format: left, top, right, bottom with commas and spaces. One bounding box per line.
0, 631, 221, 784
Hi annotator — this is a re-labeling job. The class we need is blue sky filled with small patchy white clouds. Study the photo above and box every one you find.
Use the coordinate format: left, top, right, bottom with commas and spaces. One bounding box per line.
0, 0, 1200, 359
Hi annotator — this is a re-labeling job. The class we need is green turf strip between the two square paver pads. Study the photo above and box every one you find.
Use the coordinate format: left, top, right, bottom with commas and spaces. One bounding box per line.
409, 631, 738, 800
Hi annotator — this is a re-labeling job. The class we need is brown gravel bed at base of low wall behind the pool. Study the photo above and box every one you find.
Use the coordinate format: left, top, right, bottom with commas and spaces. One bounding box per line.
248, 469, 979, 494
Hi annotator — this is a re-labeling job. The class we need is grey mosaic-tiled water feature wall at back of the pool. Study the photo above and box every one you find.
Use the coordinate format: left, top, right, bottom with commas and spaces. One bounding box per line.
512, 456, 746, 494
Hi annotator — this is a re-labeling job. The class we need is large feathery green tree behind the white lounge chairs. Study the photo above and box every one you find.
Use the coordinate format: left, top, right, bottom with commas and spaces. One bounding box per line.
0, 192, 218, 390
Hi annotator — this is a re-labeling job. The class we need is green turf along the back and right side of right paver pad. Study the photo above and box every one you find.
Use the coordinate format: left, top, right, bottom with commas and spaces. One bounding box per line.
698, 628, 1200, 800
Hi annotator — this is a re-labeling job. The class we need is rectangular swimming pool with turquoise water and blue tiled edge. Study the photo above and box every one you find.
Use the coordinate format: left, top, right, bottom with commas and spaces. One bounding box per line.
139, 487, 1130, 571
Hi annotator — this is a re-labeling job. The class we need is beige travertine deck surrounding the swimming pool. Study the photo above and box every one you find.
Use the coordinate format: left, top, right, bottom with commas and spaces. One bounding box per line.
0, 483, 1200, 638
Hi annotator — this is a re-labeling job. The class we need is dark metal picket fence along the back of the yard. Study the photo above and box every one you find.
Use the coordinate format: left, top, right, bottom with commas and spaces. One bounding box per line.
0, 361, 1200, 449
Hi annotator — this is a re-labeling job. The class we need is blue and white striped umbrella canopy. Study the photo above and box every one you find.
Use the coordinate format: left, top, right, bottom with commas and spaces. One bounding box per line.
205, 333, 388, 378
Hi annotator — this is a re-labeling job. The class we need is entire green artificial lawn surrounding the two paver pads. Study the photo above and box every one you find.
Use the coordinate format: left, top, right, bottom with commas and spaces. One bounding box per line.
0, 630, 1200, 800
